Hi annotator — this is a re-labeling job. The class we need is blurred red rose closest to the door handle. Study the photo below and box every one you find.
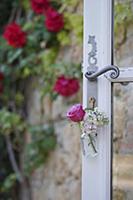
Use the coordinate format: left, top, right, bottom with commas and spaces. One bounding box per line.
54, 76, 79, 97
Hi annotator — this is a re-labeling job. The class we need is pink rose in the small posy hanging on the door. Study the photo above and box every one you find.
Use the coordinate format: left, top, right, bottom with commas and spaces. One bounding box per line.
67, 104, 85, 122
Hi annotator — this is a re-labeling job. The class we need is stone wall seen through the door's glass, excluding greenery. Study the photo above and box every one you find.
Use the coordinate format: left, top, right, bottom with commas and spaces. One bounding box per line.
113, 11, 133, 200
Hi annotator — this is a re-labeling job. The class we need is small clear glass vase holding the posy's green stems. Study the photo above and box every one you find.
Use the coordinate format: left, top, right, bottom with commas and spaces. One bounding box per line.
81, 131, 98, 157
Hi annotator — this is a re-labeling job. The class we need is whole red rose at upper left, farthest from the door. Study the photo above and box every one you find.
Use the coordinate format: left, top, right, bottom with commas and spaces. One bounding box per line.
3, 23, 26, 48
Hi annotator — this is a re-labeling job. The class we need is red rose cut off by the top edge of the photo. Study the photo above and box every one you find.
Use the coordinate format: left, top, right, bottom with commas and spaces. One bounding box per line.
31, 0, 49, 14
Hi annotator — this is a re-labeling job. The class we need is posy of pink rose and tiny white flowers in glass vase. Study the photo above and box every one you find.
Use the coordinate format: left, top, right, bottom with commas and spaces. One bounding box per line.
67, 104, 109, 157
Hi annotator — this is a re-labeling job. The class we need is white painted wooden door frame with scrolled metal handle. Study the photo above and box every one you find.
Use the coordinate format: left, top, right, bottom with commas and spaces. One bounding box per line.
82, 0, 133, 200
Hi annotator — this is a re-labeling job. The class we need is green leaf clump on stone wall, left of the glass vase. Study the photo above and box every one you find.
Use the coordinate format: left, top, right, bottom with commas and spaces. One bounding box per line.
24, 126, 56, 176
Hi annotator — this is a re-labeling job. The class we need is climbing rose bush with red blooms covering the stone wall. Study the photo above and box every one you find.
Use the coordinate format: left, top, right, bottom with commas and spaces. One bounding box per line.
0, 0, 82, 195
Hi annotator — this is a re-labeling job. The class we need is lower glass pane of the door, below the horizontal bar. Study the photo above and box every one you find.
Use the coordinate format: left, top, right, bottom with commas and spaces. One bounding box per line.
112, 83, 133, 200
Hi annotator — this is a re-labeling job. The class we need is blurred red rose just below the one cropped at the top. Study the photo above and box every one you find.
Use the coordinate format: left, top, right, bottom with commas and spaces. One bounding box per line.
45, 7, 64, 32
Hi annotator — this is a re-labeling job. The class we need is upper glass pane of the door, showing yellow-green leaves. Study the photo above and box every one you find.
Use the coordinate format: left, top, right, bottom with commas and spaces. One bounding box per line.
114, 0, 133, 67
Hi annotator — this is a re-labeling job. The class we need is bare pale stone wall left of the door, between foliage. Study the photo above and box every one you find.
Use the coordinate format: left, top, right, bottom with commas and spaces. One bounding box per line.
27, 12, 82, 200
